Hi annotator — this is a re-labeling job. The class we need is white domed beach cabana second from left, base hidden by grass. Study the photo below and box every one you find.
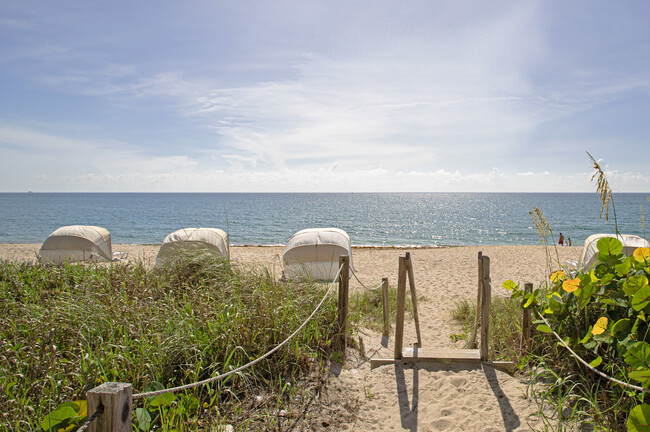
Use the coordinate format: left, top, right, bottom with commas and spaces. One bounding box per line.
155, 228, 229, 267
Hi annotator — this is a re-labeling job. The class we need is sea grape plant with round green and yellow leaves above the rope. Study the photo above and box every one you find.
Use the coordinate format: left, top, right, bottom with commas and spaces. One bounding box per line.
503, 237, 650, 431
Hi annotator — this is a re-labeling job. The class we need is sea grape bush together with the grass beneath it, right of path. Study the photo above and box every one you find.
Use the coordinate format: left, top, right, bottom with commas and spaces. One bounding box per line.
506, 237, 650, 431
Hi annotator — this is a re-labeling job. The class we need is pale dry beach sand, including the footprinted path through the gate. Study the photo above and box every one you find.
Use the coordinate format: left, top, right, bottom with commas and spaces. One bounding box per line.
0, 244, 581, 431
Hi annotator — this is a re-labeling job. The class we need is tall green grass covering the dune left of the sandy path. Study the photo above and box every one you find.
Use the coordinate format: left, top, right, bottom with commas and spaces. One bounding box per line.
0, 251, 350, 431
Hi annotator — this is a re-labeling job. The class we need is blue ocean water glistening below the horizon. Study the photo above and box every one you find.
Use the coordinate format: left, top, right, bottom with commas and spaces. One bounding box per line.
0, 193, 650, 247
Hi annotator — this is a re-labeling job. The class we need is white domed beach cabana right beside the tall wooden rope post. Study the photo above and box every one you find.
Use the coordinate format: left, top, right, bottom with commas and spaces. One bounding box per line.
282, 228, 354, 282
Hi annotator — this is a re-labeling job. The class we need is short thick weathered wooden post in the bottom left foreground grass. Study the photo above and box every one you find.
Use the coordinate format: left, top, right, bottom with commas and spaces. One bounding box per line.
86, 382, 133, 432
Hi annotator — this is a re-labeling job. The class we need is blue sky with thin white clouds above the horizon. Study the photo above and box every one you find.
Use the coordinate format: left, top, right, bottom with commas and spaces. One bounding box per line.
0, 0, 650, 192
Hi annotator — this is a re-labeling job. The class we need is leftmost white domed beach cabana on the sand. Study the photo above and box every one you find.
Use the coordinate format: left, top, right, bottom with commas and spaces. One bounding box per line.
38, 225, 112, 264
